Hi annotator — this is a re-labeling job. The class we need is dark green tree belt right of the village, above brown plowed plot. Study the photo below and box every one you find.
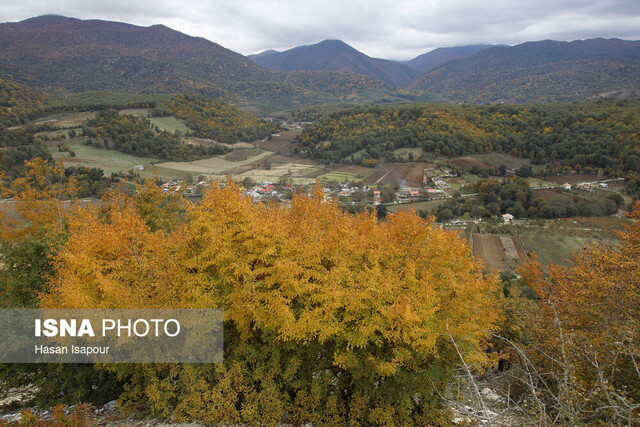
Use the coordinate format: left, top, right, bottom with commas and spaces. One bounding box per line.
435, 177, 624, 222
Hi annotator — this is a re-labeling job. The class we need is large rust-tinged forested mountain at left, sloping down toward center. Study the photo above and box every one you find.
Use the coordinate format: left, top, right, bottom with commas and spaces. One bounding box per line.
0, 15, 277, 95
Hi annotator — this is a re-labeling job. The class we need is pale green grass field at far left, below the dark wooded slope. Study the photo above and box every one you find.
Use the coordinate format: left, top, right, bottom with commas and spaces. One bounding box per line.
49, 142, 158, 174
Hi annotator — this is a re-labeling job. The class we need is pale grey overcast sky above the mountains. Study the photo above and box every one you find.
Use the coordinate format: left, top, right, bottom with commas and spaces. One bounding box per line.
0, 0, 640, 59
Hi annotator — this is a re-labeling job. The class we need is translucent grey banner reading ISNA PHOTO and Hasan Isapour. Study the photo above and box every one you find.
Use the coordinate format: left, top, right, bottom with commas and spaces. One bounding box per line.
0, 309, 223, 363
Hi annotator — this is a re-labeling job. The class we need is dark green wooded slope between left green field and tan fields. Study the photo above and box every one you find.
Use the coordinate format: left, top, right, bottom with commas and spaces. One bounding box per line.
82, 110, 229, 161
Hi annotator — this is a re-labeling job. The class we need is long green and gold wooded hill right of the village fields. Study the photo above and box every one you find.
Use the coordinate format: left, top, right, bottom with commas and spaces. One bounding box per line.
300, 99, 640, 176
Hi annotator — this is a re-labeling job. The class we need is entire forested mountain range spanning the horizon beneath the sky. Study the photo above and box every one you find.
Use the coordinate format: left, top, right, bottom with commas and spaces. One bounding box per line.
0, 15, 640, 111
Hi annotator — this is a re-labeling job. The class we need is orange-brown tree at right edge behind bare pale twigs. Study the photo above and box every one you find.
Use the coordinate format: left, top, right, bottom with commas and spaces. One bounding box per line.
522, 205, 640, 425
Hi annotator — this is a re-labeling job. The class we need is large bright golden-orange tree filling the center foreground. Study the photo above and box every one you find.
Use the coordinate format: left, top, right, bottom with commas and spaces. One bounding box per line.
41, 183, 499, 425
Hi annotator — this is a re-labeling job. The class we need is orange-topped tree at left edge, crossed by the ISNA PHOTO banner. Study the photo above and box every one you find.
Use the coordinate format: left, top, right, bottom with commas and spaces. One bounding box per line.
0, 159, 120, 405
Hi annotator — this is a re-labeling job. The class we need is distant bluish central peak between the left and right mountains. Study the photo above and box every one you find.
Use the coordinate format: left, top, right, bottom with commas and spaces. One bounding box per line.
249, 40, 418, 87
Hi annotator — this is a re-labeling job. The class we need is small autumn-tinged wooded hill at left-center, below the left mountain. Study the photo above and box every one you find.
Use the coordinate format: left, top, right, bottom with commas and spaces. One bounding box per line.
165, 94, 280, 143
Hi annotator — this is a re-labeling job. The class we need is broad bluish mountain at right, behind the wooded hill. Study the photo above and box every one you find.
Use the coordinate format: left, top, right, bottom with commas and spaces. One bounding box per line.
407, 38, 640, 103
